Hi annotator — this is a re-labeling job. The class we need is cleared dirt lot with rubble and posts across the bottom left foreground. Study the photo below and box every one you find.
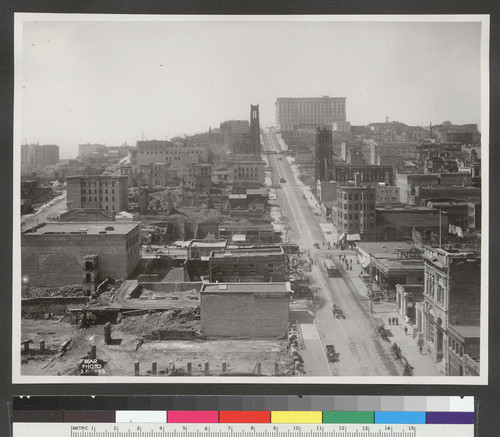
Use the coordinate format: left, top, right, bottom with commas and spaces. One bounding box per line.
21, 319, 290, 376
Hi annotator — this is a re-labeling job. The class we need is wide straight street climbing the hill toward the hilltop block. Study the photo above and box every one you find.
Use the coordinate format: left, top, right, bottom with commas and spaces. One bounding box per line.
263, 133, 401, 376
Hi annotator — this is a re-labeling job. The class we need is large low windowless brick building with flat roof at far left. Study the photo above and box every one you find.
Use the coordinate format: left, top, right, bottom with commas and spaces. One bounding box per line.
21, 222, 141, 286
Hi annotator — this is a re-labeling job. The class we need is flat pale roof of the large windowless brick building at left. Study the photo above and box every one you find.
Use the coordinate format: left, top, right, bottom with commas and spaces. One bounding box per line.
23, 222, 140, 235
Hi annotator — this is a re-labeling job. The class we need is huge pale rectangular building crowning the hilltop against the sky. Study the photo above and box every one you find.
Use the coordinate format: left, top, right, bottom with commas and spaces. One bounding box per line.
275, 96, 349, 132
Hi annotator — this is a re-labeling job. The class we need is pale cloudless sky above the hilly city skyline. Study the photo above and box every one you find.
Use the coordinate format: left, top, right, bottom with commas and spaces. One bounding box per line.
15, 17, 481, 158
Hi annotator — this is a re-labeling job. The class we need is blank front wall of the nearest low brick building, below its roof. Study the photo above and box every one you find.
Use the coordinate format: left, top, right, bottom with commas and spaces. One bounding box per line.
201, 293, 288, 338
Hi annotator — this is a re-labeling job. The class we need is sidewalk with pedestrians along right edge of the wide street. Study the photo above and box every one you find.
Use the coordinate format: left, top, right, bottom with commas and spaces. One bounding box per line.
334, 251, 441, 376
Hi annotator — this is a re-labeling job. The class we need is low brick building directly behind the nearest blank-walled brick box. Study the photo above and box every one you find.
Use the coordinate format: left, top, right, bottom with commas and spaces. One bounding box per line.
210, 246, 288, 282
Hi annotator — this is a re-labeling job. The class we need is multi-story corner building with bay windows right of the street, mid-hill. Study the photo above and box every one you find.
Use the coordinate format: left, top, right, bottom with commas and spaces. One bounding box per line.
336, 173, 376, 241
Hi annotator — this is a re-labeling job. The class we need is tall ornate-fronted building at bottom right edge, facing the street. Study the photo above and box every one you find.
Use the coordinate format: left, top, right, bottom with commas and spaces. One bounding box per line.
417, 246, 481, 373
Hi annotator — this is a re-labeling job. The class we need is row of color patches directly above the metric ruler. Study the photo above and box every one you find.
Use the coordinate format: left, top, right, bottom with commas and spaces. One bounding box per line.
10, 410, 474, 425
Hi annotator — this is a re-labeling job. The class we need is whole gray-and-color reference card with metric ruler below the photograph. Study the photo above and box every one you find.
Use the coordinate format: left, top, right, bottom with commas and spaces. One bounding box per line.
12, 396, 474, 437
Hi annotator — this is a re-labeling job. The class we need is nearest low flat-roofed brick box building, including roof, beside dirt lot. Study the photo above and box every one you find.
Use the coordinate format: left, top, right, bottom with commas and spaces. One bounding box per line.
200, 282, 293, 338
